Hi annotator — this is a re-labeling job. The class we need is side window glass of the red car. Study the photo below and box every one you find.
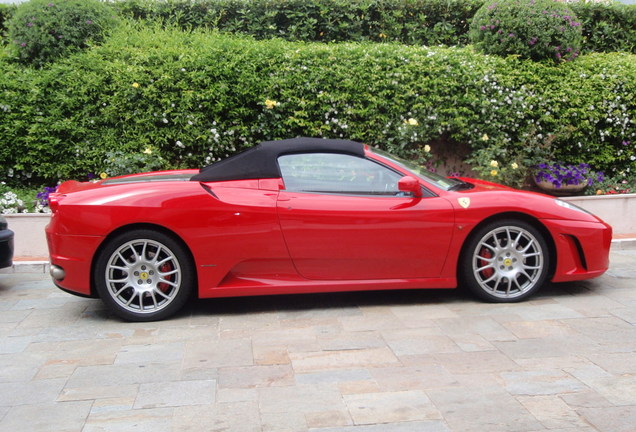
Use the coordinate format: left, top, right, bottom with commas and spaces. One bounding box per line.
278, 153, 402, 196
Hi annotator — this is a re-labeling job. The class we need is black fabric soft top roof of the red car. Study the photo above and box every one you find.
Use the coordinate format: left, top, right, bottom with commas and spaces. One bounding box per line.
191, 138, 364, 182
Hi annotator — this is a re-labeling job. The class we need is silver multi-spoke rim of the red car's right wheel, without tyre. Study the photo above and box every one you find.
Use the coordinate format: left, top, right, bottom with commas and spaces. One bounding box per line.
471, 226, 545, 299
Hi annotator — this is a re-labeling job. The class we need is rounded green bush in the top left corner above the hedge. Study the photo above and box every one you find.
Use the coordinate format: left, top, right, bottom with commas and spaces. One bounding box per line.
7, 0, 115, 66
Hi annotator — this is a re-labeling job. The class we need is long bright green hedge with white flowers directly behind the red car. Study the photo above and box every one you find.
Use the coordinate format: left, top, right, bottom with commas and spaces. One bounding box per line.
0, 26, 636, 184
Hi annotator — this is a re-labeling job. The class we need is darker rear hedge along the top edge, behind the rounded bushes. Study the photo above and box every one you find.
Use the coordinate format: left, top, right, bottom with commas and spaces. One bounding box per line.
110, 0, 636, 53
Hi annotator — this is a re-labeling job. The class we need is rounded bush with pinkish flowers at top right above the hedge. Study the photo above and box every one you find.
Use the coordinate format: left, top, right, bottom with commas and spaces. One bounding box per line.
470, 0, 582, 62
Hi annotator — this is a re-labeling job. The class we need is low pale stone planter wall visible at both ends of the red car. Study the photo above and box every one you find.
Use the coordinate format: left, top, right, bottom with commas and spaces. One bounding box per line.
5, 194, 636, 258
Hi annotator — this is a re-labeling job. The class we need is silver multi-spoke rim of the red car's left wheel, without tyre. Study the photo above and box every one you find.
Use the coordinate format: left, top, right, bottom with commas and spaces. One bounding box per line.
104, 239, 182, 314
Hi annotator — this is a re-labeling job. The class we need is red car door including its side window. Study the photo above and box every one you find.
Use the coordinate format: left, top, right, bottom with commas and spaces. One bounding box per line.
277, 153, 454, 280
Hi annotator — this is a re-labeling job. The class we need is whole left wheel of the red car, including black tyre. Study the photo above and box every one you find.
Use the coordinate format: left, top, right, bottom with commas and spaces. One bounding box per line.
93, 229, 195, 321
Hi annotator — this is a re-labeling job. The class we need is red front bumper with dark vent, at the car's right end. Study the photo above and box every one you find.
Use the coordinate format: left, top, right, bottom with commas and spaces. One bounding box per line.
542, 220, 612, 282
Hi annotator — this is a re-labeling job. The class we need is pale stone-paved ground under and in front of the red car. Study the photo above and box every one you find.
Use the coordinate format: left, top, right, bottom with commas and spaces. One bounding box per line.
0, 250, 636, 432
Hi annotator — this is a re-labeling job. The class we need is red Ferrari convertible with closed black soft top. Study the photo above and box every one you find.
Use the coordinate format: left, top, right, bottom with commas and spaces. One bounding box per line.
46, 138, 612, 321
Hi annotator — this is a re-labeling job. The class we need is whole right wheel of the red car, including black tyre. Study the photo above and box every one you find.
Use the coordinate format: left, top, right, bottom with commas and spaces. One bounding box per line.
459, 219, 550, 303
